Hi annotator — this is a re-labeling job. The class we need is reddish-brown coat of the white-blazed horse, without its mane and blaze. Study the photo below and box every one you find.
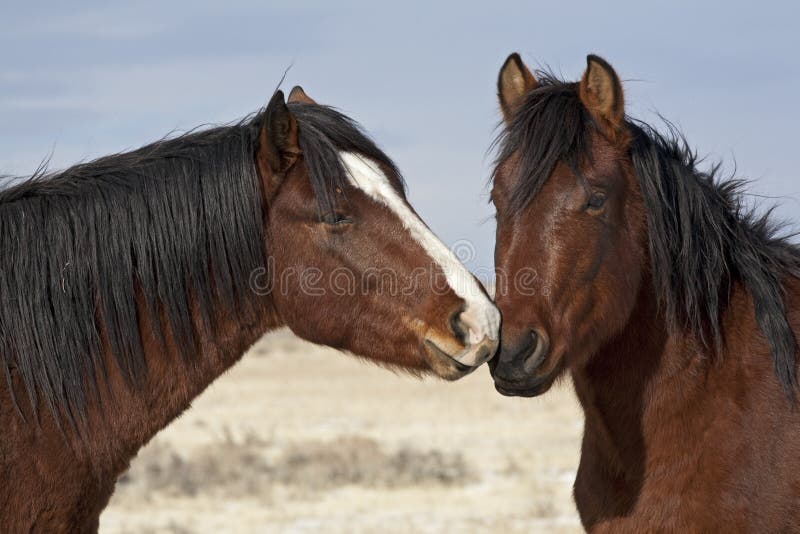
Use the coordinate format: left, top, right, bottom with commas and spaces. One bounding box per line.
0, 90, 478, 534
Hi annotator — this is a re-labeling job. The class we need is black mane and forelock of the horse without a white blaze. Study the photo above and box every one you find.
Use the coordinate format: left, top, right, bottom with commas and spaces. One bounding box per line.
495, 72, 800, 397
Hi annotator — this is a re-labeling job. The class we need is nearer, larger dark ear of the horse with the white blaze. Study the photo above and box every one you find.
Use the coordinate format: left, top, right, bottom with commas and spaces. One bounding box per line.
256, 91, 301, 198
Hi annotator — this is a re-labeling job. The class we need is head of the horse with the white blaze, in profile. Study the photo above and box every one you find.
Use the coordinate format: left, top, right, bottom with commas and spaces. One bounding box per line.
256, 87, 500, 379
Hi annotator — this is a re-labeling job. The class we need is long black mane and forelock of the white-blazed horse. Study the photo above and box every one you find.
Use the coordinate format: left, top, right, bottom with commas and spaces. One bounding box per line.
0, 98, 399, 426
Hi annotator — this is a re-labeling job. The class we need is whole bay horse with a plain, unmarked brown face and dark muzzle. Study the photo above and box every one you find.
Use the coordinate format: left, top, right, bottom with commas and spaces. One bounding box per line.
490, 54, 800, 533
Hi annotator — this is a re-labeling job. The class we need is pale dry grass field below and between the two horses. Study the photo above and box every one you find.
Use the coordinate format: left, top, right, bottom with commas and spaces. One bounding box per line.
101, 332, 582, 534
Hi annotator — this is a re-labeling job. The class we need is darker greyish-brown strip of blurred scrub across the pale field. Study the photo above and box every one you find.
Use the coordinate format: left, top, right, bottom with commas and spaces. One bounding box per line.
117, 434, 476, 501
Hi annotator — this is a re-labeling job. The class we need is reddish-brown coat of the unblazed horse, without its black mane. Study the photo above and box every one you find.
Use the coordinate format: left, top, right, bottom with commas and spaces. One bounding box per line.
490, 56, 800, 533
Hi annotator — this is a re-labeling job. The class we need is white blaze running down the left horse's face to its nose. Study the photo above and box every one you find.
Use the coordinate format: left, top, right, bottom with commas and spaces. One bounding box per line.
339, 152, 500, 343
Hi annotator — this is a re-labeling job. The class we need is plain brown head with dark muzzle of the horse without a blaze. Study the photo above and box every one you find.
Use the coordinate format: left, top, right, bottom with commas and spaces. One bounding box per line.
490, 54, 647, 396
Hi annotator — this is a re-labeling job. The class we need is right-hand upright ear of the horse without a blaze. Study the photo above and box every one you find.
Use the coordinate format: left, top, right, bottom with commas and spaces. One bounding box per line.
580, 54, 625, 138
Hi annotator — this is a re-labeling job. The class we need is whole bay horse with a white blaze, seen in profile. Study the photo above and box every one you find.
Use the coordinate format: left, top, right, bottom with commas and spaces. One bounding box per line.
0, 87, 500, 533
